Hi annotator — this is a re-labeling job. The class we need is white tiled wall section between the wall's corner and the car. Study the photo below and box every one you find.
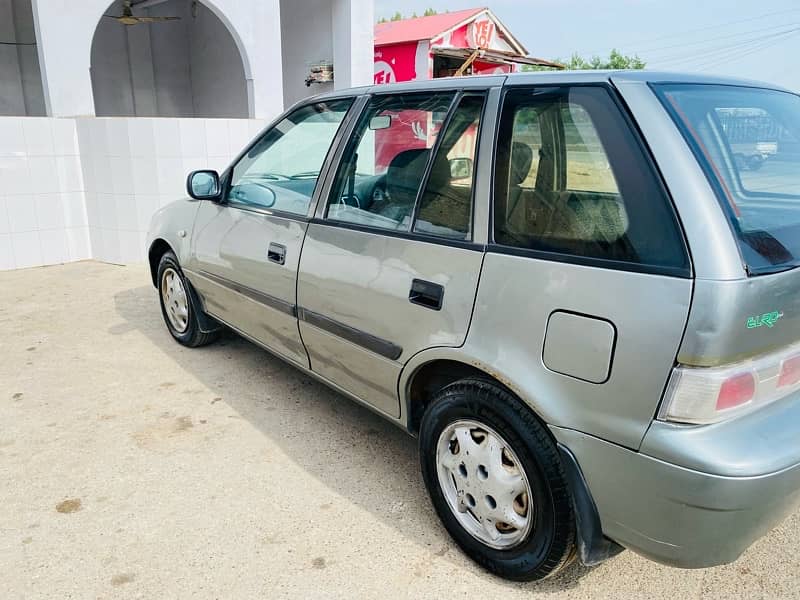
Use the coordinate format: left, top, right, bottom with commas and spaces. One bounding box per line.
76, 117, 265, 263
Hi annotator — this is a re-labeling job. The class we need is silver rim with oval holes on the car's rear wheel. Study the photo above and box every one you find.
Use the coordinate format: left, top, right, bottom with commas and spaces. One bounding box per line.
436, 420, 534, 550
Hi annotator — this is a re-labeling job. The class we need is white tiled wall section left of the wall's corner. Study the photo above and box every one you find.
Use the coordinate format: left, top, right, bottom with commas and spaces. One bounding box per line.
0, 117, 91, 269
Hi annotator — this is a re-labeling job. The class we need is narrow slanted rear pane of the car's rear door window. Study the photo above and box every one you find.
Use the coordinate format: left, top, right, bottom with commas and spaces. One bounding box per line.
414, 96, 484, 240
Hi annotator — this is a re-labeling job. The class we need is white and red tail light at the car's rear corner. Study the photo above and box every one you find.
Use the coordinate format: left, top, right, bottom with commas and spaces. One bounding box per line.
658, 345, 800, 424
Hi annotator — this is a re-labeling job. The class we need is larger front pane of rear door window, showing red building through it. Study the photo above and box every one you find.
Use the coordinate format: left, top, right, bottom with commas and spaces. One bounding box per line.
327, 93, 453, 231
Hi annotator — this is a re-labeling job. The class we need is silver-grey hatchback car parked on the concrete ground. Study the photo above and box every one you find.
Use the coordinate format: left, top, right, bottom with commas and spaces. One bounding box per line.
148, 72, 800, 580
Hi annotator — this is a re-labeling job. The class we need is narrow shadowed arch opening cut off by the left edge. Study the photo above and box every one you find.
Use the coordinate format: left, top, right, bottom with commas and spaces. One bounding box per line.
0, 0, 46, 117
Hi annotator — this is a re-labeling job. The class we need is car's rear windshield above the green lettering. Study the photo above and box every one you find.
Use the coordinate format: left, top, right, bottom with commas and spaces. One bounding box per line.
655, 84, 800, 274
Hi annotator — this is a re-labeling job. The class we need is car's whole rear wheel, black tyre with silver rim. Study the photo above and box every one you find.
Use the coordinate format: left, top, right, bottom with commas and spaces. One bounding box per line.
420, 379, 575, 581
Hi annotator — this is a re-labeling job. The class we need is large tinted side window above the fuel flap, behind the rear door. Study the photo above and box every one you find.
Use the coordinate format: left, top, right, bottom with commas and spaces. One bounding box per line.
494, 86, 688, 269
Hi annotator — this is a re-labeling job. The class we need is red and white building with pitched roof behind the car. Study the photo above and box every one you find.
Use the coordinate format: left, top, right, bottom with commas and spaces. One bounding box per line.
375, 8, 560, 84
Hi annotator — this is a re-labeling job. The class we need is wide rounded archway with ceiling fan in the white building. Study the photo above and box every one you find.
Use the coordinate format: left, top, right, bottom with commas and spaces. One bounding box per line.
91, 0, 251, 117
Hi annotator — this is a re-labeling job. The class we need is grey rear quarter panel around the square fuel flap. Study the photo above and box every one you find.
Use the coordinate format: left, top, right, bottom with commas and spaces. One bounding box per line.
463, 252, 692, 448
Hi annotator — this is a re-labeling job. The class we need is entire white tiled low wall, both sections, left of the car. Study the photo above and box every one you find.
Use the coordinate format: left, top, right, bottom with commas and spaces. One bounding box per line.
0, 117, 266, 269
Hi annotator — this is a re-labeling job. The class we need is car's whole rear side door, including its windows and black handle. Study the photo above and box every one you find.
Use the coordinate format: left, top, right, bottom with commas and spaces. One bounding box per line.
298, 90, 494, 417
